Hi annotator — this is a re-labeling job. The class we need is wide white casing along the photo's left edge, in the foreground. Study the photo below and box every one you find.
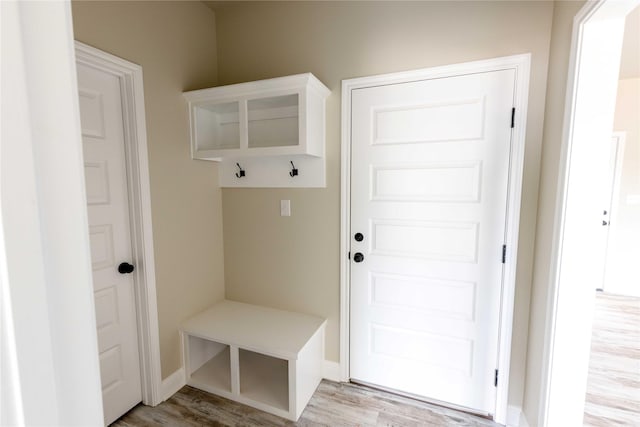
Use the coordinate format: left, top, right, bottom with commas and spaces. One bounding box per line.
0, 1, 103, 426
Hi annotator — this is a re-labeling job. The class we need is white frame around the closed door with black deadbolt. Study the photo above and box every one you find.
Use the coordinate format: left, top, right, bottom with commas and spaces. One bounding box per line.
340, 54, 531, 424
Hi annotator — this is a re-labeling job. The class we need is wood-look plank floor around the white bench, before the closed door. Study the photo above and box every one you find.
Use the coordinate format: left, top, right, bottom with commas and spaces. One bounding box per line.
112, 381, 500, 427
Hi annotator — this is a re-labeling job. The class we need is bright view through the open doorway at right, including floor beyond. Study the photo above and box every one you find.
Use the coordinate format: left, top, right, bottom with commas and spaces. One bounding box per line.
584, 10, 640, 426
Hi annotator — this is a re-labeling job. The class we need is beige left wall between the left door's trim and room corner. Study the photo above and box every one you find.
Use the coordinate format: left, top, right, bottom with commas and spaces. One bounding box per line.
72, 1, 224, 378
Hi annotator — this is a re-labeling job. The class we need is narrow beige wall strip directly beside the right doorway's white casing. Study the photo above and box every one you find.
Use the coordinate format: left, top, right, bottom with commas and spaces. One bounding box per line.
523, 1, 584, 426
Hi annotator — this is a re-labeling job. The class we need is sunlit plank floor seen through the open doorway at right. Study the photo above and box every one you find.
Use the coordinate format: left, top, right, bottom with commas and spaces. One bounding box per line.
584, 292, 640, 427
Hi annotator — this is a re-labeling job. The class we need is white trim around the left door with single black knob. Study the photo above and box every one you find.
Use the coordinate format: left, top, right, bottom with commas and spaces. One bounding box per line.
75, 41, 164, 406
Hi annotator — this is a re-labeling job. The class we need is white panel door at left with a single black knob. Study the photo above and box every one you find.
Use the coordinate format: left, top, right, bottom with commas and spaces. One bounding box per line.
77, 64, 142, 424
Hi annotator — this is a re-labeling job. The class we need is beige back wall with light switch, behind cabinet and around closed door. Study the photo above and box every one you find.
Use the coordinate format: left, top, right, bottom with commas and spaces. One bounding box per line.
216, 1, 553, 412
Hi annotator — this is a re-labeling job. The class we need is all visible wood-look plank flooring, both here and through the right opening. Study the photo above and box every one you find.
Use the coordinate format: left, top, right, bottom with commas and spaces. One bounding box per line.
112, 293, 640, 427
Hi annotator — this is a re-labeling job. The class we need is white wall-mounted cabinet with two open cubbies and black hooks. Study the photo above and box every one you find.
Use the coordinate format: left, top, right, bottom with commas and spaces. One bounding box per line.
184, 73, 330, 187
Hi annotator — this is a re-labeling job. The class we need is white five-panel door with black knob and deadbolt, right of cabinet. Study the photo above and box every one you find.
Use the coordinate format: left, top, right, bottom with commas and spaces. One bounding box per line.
350, 70, 515, 414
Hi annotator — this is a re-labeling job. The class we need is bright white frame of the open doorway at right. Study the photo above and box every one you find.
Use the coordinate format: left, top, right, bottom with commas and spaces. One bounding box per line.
538, 0, 640, 426
